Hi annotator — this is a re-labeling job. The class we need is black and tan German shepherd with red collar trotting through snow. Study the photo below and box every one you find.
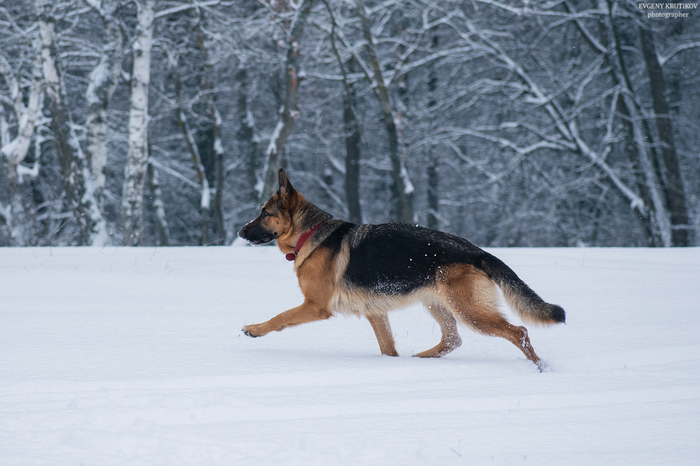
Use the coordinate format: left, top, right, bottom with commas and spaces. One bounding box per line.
238, 170, 565, 370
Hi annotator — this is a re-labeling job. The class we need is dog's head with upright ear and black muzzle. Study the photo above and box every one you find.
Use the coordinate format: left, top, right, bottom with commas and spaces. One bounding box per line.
238, 168, 301, 244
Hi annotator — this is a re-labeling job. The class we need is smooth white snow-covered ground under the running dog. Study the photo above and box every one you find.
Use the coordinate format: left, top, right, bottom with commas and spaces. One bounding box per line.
0, 247, 700, 466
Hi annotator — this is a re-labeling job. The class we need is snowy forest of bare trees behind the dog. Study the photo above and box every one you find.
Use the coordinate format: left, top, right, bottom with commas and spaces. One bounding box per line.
0, 0, 700, 247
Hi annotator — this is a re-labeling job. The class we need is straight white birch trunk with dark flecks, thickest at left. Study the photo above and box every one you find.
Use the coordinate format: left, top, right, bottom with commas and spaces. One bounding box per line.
122, 0, 156, 246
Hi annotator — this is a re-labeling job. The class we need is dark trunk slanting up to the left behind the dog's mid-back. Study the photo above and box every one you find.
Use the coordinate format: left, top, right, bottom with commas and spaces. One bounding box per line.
355, 0, 414, 222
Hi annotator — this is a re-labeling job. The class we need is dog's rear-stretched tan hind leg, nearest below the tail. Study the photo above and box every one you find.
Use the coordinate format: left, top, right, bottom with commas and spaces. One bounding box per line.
438, 265, 540, 367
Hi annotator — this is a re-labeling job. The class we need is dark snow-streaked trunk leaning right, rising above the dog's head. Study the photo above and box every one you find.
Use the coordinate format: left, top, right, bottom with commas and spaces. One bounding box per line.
258, 0, 315, 203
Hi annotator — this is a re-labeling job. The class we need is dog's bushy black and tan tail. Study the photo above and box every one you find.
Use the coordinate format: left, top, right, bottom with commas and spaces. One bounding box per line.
482, 255, 566, 324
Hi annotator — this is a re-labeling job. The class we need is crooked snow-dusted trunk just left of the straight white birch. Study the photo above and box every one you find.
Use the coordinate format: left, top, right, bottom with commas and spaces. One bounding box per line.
85, 0, 122, 209
